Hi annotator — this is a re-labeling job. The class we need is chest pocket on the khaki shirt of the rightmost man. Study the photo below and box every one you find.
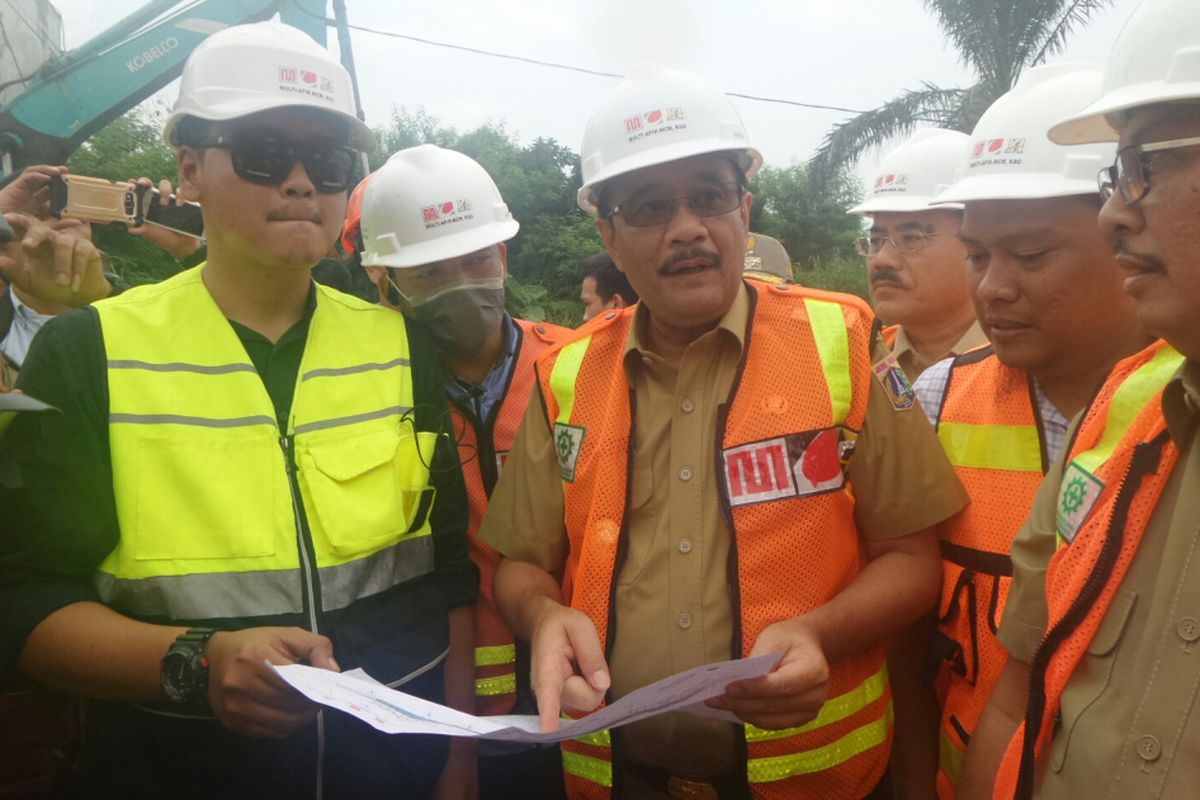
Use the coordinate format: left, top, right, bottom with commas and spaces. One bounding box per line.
1050, 588, 1138, 772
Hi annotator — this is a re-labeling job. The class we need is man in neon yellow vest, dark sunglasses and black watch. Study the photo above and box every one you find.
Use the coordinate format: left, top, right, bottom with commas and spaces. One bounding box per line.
0, 23, 478, 798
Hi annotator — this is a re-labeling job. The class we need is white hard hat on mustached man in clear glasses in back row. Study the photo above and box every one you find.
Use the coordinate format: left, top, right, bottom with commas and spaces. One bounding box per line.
847, 128, 968, 217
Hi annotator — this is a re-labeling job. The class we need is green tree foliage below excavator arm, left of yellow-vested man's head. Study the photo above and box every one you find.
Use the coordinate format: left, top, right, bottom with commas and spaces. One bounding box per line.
67, 112, 179, 284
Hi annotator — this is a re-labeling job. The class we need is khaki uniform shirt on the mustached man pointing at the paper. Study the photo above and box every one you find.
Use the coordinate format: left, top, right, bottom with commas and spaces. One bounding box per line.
479, 288, 966, 776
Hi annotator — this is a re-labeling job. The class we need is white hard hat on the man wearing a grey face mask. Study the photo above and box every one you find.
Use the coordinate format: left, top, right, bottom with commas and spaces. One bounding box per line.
362, 144, 521, 266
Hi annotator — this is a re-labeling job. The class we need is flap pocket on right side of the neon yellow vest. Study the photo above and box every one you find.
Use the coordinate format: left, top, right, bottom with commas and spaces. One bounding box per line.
296, 427, 436, 561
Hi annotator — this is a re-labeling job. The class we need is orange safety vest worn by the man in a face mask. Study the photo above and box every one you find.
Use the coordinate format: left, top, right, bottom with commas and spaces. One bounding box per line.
450, 319, 570, 715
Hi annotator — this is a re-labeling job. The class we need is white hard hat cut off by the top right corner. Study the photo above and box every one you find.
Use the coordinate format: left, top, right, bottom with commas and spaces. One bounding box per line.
1050, 0, 1200, 144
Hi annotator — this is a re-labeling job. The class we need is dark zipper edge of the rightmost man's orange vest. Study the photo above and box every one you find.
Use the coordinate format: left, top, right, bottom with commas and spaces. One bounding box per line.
1015, 435, 1165, 800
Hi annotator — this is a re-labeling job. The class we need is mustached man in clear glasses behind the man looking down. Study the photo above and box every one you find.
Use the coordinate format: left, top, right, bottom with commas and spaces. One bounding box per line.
850, 128, 988, 381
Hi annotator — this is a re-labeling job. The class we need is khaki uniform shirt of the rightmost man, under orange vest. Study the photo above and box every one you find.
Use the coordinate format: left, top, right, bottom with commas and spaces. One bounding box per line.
1000, 361, 1200, 800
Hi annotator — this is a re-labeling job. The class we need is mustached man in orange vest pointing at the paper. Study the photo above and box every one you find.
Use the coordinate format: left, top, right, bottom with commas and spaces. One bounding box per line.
480, 64, 962, 798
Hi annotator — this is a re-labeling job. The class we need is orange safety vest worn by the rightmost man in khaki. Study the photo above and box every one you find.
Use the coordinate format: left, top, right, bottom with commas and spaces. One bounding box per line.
994, 341, 1183, 798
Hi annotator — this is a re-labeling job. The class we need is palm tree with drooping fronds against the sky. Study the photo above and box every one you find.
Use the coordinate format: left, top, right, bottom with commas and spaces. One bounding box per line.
809, 0, 1112, 180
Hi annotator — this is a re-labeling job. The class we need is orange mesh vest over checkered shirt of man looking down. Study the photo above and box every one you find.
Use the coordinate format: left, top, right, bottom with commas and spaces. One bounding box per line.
937, 345, 1048, 798
